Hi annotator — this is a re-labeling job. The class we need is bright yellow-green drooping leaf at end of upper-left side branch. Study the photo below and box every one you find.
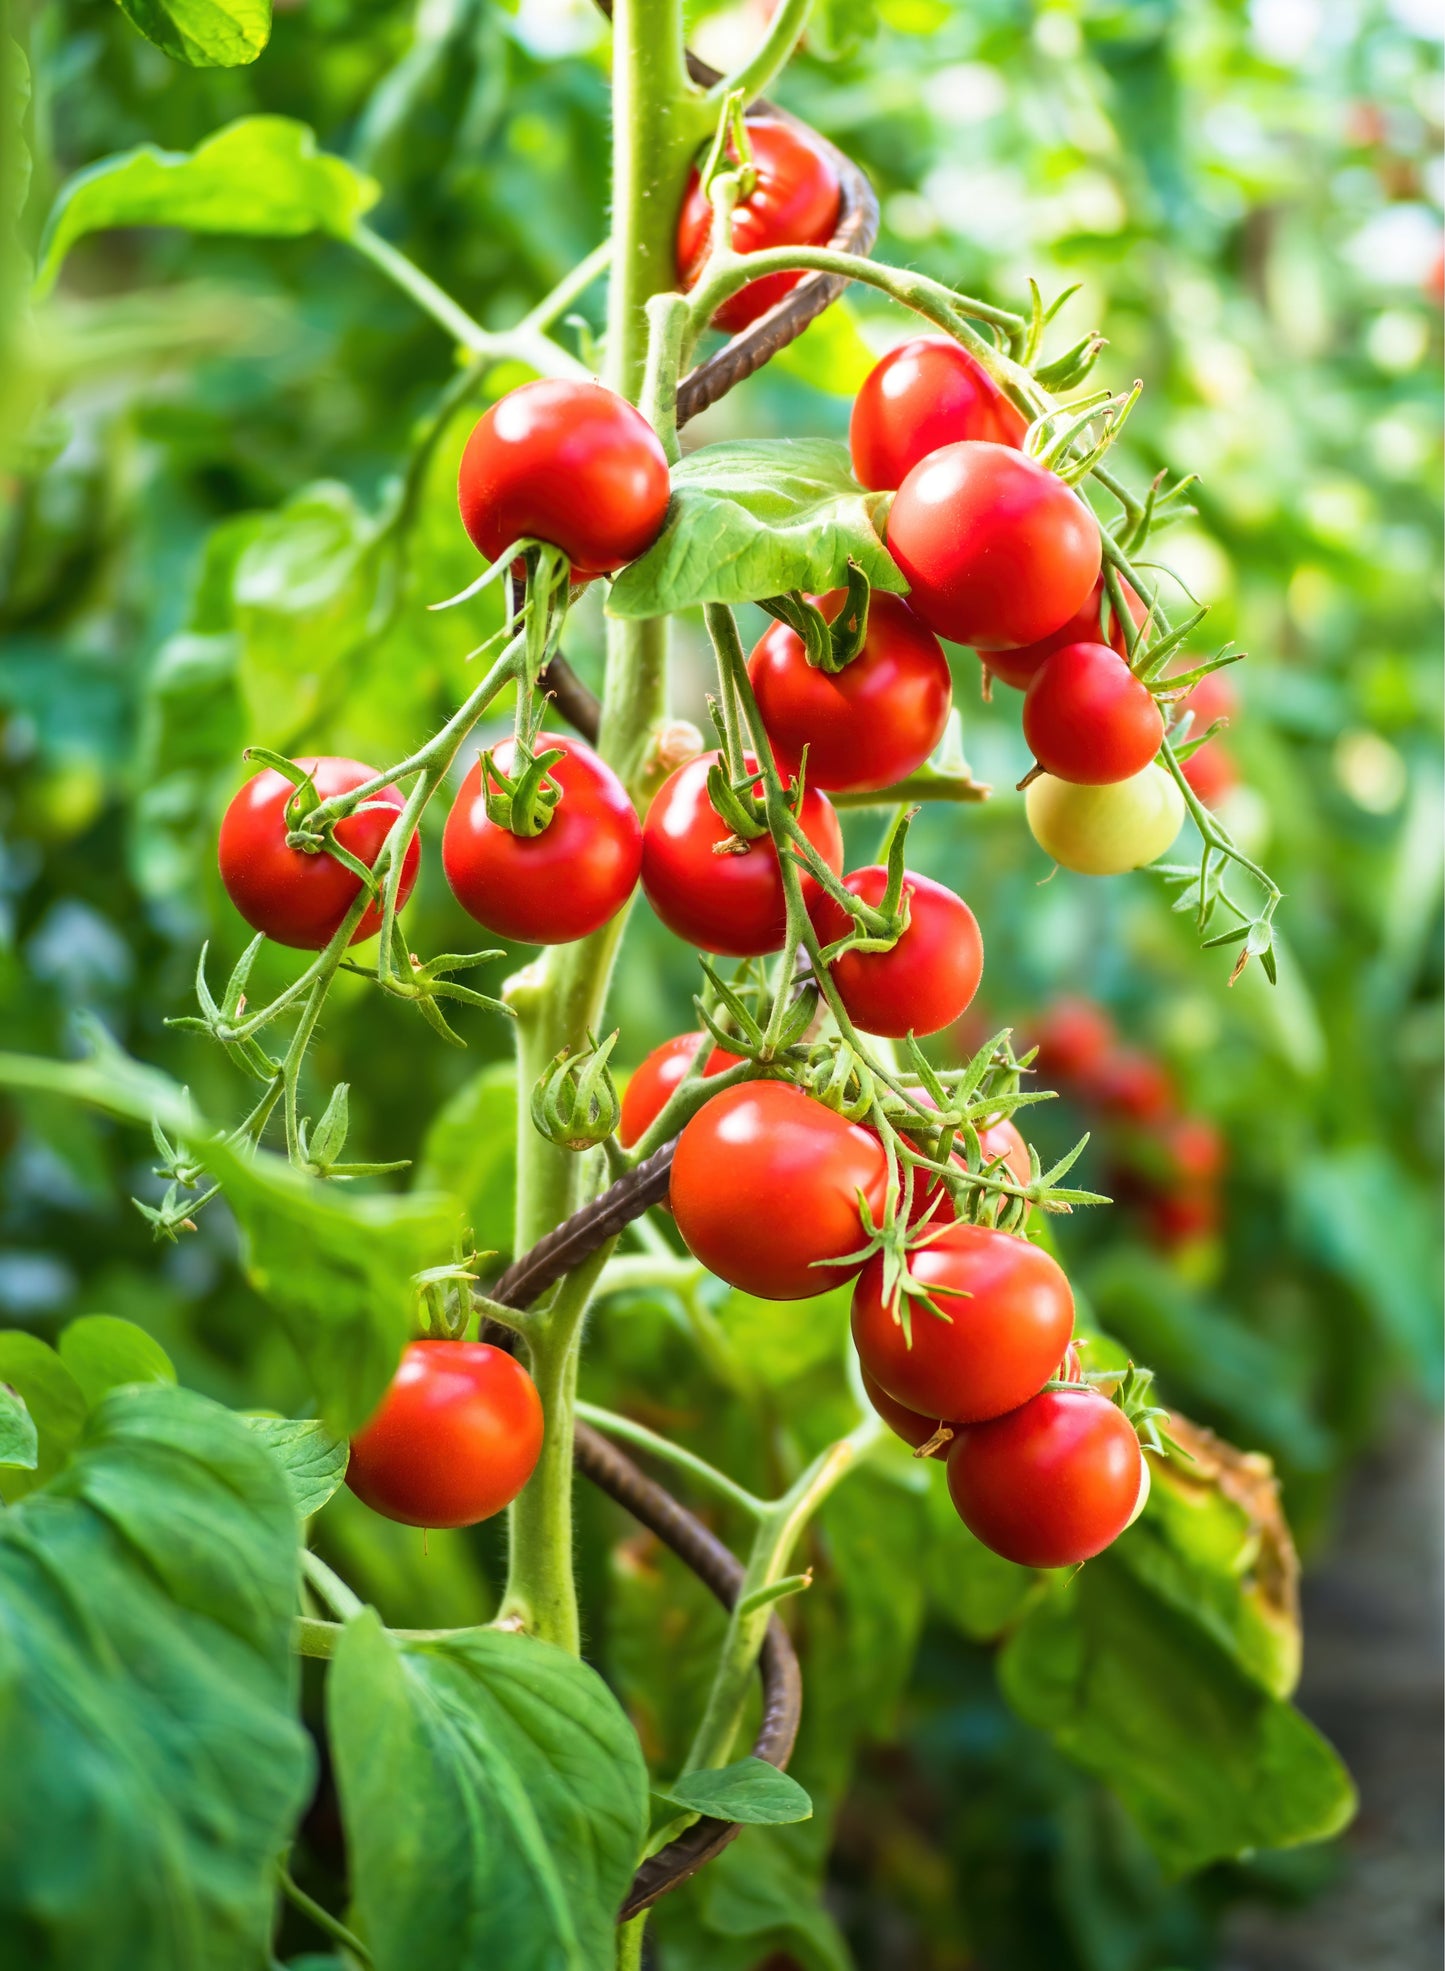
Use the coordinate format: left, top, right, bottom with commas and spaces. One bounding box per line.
35, 116, 380, 294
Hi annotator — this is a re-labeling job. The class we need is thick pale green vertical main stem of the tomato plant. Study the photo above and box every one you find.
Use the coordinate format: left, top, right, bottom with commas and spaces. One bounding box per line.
503, 0, 708, 1654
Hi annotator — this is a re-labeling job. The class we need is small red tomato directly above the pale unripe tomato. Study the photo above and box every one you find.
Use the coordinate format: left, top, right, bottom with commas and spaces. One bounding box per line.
1023, 643, 1163, 786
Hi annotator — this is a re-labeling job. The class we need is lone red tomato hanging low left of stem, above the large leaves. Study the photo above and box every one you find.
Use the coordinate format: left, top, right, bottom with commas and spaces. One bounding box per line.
347, 1340, 542, 1528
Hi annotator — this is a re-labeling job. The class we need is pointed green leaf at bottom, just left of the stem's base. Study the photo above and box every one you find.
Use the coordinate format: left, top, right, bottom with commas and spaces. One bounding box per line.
327, 1610, 647, 1971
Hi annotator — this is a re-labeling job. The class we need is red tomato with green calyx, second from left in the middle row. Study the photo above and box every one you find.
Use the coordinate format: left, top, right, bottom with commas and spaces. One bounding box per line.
442, 733, 643, 944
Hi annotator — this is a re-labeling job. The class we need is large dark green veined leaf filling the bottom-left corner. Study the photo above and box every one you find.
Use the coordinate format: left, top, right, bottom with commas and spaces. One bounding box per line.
0, 1384, 311, 1971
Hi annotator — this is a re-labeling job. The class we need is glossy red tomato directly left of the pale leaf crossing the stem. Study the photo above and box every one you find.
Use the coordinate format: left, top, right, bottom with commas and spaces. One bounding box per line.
457, 376, 672, 579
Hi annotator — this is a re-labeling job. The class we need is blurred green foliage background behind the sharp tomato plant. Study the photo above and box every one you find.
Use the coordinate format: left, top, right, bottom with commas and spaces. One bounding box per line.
0, 0, 1445, 1971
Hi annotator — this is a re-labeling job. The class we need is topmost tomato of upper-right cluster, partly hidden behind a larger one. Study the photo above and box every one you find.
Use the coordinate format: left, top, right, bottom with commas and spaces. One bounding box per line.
848, 335, 1029, 491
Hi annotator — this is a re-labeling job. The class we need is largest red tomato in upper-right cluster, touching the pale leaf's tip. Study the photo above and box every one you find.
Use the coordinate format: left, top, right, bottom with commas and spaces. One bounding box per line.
887, 440, 1102, 650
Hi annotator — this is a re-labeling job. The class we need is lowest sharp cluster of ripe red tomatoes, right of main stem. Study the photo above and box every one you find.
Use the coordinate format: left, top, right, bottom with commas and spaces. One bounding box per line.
619, 1056, 1149, 1567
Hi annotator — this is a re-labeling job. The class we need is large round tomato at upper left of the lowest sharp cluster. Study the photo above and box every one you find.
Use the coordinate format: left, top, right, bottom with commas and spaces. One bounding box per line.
670, 1082, 887, 1301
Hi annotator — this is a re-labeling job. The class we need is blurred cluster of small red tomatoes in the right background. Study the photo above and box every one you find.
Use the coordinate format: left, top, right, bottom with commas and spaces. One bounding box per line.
1037, 1001, 1228, 1252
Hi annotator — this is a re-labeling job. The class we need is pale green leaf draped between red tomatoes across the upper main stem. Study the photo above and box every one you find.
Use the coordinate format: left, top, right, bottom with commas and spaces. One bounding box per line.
607, 438, 907, 617
